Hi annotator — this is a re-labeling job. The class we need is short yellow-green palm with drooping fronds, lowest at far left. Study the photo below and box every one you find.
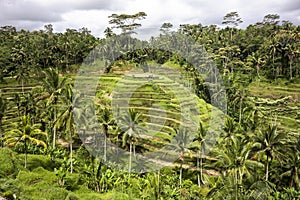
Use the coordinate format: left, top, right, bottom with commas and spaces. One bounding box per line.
3, 115, 47, 168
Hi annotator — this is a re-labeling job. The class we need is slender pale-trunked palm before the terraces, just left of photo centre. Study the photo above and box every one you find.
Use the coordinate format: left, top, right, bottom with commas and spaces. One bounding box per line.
120, 108, 144, 175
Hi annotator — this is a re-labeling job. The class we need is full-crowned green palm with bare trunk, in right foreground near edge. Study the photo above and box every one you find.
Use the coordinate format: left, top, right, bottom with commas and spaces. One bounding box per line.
253, 124, 286, 181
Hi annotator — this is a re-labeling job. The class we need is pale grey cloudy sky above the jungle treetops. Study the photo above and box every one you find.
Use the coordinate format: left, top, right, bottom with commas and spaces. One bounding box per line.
0, 0, 300, 37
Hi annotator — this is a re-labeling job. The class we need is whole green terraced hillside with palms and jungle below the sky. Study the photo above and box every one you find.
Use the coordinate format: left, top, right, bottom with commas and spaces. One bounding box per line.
0, 12, 300, 200
